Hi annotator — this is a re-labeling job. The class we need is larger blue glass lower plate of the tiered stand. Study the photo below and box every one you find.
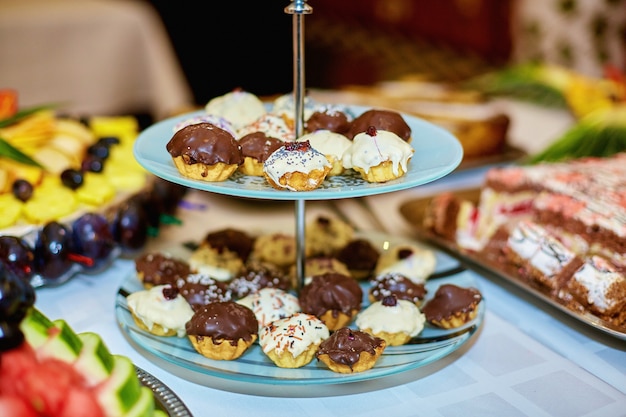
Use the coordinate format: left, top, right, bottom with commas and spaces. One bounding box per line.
115, 233, 485, 397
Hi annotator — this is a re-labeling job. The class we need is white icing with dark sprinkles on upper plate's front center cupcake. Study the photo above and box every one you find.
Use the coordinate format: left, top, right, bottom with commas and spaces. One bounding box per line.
263, 141, 332, 191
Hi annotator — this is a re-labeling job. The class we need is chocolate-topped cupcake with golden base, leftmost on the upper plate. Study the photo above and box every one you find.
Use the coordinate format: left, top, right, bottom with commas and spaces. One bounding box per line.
166, 123, 243, 182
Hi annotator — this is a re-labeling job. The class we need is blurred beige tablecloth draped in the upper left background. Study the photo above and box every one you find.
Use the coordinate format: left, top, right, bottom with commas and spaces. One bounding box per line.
0, 0, 192, 119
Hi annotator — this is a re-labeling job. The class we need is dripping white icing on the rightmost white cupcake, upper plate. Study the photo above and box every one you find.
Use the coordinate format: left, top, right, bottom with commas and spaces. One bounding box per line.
343, 130, 415, 176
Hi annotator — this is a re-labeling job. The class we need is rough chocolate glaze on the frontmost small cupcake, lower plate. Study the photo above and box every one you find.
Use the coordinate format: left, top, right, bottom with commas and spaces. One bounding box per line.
315, 327, 384, 367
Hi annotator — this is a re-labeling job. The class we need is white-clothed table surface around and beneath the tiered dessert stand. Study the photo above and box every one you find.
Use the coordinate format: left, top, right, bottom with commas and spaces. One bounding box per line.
35, 99, 626, 417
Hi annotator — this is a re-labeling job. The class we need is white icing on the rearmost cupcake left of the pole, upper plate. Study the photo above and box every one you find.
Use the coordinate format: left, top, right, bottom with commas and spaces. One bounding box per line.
204, 90, 267, 130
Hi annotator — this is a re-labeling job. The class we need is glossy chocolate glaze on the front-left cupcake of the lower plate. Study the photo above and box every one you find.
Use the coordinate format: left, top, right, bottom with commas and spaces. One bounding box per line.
185, 301, 259, 345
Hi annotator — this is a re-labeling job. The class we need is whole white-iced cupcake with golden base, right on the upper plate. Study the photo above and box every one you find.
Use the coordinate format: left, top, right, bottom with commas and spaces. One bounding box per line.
342, 126, 415, 183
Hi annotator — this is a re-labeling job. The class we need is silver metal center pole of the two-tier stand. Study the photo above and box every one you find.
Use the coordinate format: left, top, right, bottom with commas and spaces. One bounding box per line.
285, 0, 313, 291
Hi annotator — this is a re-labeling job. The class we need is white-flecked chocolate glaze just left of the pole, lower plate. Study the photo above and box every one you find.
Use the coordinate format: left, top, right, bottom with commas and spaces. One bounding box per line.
229, 261, 291, 298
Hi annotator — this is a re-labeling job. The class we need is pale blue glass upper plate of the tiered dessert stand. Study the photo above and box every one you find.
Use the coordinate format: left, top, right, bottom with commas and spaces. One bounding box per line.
134, 106, 463, 200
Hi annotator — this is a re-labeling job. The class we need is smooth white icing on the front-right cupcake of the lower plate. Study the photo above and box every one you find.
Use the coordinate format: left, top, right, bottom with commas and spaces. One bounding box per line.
355, 300, 426, 337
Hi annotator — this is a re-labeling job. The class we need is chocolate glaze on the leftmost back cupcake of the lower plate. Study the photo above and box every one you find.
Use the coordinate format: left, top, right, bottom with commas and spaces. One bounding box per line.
135, 252, 191, 285
